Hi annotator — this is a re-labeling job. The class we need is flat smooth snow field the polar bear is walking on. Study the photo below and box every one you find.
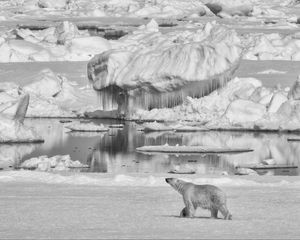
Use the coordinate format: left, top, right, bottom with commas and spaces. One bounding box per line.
0, 174, 300, 239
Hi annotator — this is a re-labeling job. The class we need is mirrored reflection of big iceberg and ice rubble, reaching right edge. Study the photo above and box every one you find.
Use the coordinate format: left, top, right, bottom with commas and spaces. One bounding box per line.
84, 124, 300, 175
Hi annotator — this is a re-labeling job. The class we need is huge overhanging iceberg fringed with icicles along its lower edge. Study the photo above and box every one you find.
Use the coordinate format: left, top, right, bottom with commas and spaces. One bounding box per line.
88, 20, 242, 113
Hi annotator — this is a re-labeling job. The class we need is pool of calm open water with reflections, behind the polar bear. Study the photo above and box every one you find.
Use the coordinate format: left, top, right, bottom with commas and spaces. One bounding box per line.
0, 119, 300, 175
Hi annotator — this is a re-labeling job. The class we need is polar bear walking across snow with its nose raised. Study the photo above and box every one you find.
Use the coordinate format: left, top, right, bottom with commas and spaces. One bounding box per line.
166, 178, 232, 220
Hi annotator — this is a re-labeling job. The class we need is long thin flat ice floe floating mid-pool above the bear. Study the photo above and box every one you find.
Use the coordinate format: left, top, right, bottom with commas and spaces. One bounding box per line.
136, 144, 253, 154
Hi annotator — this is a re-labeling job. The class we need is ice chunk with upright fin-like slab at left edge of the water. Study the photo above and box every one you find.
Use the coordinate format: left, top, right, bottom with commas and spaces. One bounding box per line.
0, 93, 44, 143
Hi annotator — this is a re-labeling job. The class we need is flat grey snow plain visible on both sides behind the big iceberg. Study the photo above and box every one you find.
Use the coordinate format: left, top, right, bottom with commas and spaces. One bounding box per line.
0, 60, 300, 87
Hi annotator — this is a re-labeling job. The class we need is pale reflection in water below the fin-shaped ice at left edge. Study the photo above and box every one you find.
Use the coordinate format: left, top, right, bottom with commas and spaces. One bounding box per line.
0, 144, 41, 169
